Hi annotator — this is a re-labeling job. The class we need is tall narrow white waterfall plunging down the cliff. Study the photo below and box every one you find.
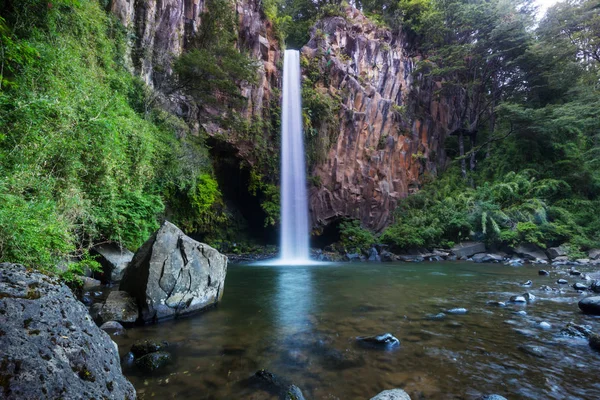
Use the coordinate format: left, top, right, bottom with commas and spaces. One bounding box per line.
279, 50, 310, 264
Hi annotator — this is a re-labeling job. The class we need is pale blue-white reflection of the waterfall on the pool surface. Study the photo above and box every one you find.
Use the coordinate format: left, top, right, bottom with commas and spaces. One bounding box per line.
273, 267, 315, 335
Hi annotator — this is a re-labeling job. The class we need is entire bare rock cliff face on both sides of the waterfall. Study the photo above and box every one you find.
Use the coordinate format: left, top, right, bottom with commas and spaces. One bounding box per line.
111, 0, 458, 231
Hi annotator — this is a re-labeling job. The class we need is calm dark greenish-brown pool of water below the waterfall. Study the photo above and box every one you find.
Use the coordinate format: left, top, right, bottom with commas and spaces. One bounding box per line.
115, 262, 600, 400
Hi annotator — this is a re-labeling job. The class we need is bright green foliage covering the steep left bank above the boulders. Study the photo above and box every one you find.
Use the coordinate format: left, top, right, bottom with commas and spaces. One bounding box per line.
0, 0, 217, 270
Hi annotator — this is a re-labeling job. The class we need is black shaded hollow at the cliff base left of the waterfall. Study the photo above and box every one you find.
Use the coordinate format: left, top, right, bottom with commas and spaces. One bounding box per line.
207, 138, 278, 245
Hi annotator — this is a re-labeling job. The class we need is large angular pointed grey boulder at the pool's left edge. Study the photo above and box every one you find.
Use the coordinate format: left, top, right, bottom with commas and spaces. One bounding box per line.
119, 221, 227, 322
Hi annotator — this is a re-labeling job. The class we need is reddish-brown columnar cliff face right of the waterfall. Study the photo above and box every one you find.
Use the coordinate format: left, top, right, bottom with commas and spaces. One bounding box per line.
302, 7, 458, 231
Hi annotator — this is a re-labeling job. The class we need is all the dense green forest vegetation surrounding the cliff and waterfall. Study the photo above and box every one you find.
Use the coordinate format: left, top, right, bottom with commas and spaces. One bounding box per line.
0, 0, 600, 276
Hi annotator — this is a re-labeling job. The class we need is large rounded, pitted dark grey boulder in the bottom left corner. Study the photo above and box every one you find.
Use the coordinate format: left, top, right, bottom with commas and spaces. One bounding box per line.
0, 263, 136, 400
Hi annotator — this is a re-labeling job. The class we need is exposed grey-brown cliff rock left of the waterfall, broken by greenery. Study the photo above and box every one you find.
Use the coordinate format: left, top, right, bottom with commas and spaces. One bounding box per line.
110, 0, 281, 147
